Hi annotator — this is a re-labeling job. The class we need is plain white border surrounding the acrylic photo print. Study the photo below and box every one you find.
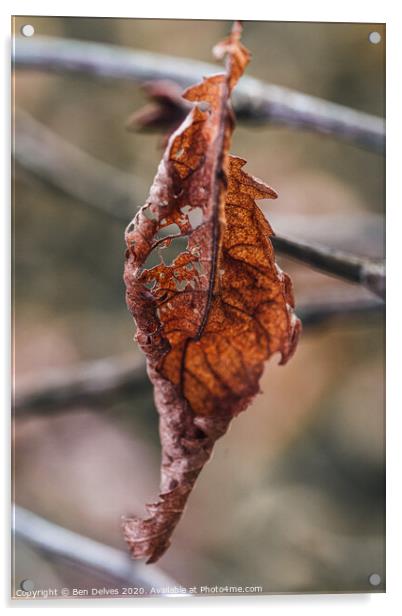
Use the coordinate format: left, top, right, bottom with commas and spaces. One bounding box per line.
0, 0, 402, 616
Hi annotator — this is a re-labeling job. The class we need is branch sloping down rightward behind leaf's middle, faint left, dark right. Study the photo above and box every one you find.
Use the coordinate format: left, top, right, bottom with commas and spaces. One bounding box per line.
14, 111, 385, 298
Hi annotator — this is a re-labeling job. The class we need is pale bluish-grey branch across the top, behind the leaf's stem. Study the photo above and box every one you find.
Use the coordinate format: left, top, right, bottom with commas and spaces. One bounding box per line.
13, 36, 385, 153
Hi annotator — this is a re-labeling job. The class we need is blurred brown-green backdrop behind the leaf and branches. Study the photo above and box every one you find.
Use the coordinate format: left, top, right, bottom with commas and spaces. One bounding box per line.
13, 17, 385, 592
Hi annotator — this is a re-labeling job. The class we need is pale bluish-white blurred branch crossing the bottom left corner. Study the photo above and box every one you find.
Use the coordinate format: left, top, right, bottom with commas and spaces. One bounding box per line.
13, 505, 177, 591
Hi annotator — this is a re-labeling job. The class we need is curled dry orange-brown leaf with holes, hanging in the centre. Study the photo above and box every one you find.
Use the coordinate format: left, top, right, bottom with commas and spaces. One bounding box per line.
123, 22, 300, 563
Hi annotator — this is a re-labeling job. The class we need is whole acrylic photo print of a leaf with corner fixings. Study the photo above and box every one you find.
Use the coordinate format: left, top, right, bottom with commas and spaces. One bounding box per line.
12, 16, 385, 600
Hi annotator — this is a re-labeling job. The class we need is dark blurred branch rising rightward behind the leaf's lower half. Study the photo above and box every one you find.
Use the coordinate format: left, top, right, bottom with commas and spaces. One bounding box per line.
14, 299, 384, 418
